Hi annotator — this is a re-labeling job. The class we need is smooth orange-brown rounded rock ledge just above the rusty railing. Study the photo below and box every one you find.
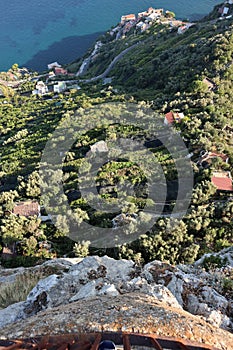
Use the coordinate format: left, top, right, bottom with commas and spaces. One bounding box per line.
2, 293, 233, 350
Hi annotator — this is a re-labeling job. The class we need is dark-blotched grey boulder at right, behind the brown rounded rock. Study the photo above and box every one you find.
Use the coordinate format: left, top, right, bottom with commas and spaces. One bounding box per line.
142, 258, 233, 330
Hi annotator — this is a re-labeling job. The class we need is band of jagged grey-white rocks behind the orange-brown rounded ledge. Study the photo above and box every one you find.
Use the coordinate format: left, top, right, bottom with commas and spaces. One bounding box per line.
0, 251, 233, 330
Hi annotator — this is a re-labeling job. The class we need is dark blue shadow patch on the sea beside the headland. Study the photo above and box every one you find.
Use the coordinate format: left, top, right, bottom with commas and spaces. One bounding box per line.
23, 32, 103, 71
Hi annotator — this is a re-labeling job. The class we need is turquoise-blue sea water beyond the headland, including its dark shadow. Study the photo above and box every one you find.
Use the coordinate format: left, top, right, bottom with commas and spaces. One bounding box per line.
0, 0, 220, 71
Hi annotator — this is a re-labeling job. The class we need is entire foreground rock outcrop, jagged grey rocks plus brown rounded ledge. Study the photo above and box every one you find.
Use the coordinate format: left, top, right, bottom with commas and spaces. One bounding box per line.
0, 248, 233, 349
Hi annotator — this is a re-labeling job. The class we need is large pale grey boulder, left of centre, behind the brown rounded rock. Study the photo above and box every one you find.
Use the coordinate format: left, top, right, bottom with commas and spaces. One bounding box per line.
13, 256, 134, 317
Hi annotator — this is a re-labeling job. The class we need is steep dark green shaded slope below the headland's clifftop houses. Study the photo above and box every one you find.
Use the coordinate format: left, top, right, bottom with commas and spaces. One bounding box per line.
75, 5, 233, 99
